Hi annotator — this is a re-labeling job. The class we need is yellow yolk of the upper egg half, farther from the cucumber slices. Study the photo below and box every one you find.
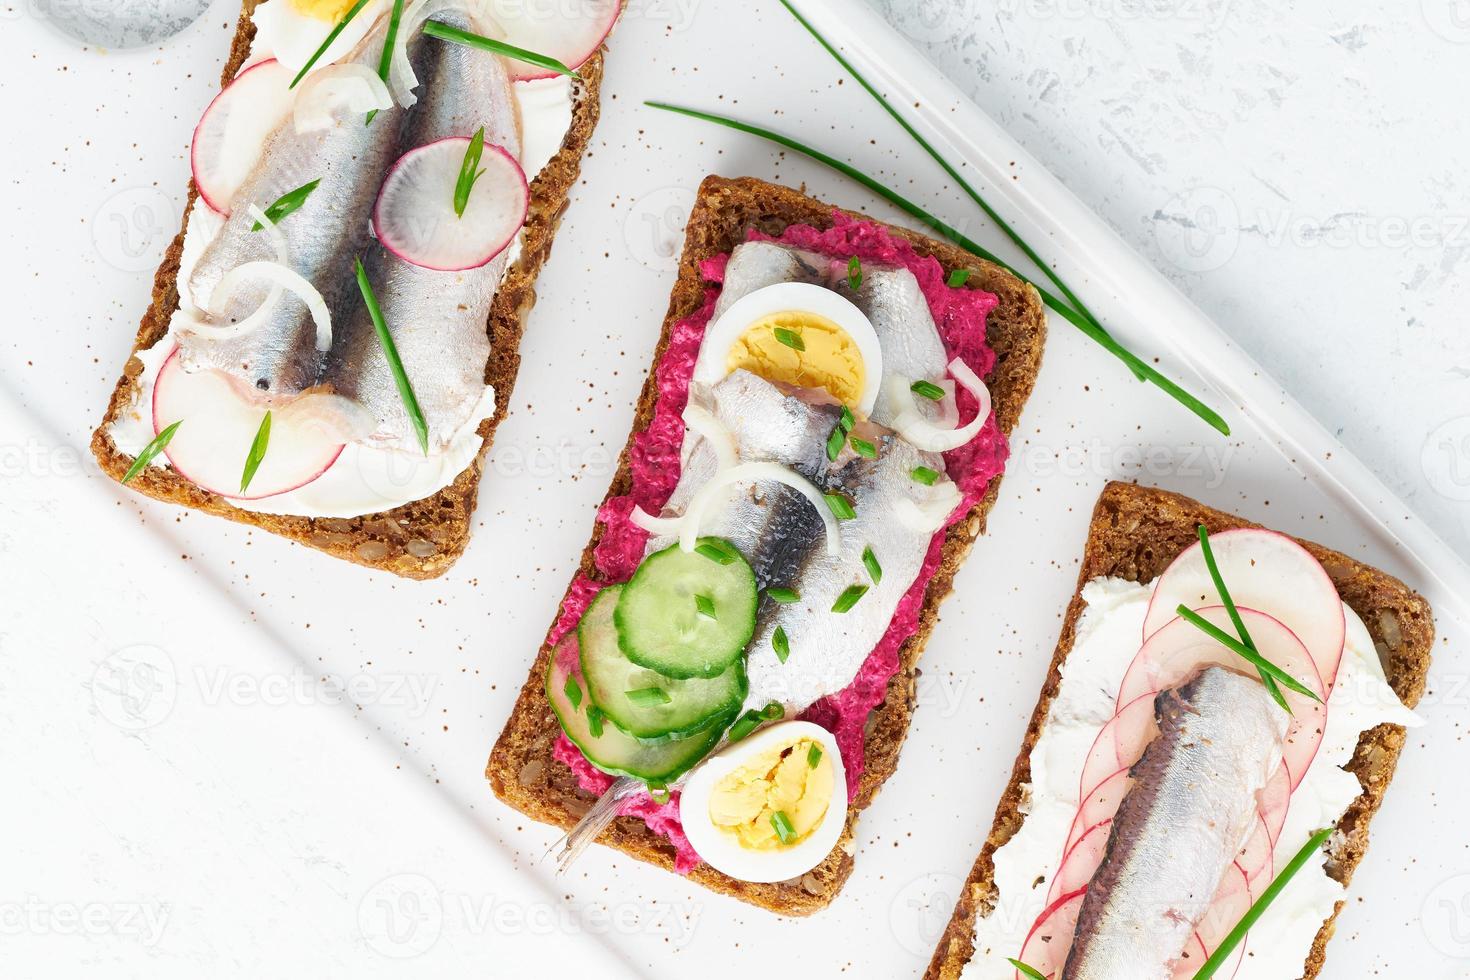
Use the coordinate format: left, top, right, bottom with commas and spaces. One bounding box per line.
726, 310, 867, 406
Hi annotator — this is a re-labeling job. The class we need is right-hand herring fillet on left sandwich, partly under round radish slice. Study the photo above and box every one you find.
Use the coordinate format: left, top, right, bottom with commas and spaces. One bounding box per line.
323, 12, 520, 454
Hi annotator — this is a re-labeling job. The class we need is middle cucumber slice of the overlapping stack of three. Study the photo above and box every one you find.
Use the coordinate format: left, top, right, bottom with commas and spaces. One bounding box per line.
576, 587, 748, 741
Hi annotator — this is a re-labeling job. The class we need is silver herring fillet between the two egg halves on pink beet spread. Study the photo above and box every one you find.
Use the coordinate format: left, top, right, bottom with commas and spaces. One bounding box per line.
648, 370, 953, 717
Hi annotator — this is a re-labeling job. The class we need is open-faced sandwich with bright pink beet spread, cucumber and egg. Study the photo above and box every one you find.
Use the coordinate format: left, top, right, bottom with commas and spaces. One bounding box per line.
488, 176, 1045, 914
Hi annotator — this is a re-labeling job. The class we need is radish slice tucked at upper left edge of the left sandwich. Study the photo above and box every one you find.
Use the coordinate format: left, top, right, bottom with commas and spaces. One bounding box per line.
190, 59, 293, 215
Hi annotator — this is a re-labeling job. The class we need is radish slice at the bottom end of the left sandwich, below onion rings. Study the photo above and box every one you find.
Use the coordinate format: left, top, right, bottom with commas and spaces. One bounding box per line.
153, 350, 363, 500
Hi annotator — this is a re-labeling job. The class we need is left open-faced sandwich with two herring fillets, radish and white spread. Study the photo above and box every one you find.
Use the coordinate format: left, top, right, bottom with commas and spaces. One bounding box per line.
93, 0, 620, 577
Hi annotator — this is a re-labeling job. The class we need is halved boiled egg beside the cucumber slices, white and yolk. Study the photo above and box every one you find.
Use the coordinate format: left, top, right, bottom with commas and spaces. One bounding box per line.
679, 721, 847, 882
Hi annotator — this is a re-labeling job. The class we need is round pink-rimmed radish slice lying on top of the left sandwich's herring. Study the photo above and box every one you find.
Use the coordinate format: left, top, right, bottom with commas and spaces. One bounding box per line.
372, 137, 531, 272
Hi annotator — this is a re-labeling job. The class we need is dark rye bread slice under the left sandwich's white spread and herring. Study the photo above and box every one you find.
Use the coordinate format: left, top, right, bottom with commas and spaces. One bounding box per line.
91, 0, 606, 579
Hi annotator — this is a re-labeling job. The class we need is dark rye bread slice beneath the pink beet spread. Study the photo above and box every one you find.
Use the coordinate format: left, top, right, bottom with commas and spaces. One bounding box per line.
485, 176, 1047, 915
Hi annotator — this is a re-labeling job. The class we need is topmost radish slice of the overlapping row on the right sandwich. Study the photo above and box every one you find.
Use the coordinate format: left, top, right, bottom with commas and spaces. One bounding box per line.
1144, 527, 1347, 691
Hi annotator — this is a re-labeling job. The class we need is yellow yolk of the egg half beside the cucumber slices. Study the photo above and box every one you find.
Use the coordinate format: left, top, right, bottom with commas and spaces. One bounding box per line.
710, 739, 832, 851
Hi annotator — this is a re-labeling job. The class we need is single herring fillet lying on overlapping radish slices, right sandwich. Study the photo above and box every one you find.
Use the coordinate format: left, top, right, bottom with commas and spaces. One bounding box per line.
1061, 667, 1289, 980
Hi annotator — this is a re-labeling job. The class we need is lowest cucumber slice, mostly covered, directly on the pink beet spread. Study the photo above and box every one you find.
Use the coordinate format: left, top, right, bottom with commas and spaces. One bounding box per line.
547, 633, 735, 783
